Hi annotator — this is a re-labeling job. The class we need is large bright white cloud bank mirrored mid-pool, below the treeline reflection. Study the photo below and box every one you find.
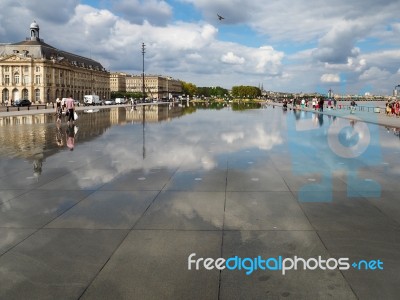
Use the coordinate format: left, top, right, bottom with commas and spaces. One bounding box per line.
54, 111, 283, 188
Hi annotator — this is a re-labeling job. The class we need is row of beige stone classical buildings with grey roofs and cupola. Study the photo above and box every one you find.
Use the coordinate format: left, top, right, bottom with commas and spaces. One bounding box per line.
0, 22, 182, 104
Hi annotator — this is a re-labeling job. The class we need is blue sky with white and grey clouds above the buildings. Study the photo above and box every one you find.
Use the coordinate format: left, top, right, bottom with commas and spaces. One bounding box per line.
0, 0, 400, 95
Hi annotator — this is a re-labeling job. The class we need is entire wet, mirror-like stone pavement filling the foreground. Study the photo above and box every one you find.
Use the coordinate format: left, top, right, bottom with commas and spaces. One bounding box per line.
0, 106, 400, 299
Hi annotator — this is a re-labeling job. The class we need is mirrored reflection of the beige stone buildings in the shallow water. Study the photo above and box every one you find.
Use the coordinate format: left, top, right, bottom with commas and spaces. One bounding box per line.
0, 105, 183, 176
